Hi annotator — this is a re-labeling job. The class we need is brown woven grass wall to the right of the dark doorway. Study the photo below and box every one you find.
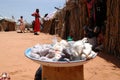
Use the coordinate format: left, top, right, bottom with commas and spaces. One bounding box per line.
105, 0, 120, 57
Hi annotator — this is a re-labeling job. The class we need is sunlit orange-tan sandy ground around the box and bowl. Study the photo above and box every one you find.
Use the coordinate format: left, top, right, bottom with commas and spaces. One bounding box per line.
0, 31, 120, 80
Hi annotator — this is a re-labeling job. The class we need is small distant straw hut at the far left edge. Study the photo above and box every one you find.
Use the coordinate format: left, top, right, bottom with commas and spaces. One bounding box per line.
0, 18, 16, 31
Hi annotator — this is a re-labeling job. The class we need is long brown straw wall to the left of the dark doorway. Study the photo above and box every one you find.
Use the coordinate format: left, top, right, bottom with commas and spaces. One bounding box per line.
43, 0, 86, 40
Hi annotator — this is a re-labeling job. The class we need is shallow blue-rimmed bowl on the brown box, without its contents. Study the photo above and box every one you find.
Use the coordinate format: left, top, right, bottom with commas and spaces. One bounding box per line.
25, 48, 96, 67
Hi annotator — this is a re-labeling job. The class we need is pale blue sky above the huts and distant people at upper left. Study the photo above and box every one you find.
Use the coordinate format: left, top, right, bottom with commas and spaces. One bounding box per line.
0, 0, 66, 22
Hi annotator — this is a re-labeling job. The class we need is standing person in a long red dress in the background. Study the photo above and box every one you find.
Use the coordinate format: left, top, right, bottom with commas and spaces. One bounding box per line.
32, 9, 40, 35
